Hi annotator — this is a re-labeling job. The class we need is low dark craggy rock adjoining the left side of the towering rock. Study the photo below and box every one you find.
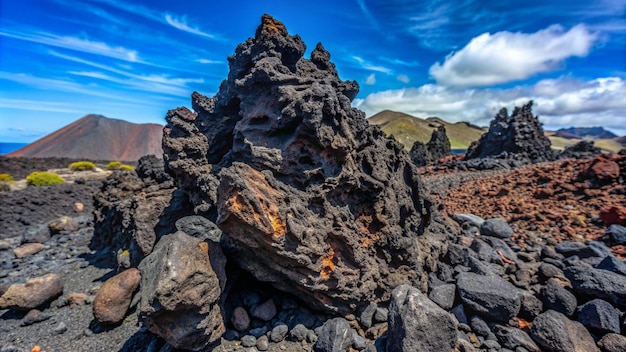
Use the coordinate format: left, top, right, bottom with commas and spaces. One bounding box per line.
90, 155, 192, 267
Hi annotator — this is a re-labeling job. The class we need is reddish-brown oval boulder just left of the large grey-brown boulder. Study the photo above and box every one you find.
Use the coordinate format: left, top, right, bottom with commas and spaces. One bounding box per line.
93, 268, 141, 324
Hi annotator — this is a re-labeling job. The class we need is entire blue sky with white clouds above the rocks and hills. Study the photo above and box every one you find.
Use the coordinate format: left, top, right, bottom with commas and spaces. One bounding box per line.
0, 0, 626, 142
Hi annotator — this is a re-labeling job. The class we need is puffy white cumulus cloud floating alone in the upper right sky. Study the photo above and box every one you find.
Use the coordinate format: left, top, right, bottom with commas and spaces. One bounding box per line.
429, 24, 597, 87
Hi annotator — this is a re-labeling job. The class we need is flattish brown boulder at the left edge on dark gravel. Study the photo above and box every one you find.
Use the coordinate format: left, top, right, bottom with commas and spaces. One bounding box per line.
0, 274, 63, 310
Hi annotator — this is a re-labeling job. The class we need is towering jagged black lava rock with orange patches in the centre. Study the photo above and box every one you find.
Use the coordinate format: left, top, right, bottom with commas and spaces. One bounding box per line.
163, 15, 446, 314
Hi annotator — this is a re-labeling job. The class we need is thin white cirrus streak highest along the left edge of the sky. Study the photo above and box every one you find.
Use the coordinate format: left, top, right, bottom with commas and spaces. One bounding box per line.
0, 30, 140, 62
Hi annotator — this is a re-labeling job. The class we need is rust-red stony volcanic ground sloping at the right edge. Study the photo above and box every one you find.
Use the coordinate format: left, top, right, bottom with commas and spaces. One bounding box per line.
424, 154, 626, 258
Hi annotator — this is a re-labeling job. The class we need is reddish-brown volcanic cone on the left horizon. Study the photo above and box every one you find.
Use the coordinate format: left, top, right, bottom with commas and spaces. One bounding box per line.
7, 115, 163, 161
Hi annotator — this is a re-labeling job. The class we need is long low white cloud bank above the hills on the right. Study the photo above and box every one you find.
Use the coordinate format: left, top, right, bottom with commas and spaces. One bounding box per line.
353, 77, 626, 135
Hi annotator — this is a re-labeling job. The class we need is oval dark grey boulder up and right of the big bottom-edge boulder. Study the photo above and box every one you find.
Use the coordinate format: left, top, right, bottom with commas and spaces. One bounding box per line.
457, 273, 521, 322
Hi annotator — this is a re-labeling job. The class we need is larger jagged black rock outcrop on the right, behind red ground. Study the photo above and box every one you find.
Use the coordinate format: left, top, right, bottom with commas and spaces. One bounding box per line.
465, 101, 554, 163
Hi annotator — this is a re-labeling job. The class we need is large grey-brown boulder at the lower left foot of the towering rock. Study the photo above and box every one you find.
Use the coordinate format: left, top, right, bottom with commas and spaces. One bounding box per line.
139, 231, 225, 351
